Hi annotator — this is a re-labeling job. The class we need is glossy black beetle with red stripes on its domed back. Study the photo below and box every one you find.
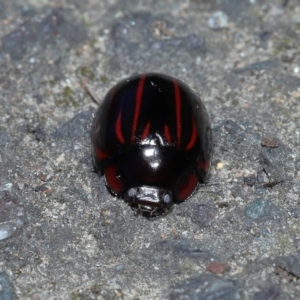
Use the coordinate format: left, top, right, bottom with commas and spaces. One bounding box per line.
92, 73, 212, 217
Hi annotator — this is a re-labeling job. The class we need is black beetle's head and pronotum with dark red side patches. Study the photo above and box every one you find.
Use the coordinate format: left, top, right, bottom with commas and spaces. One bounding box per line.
104, 145, 198, 217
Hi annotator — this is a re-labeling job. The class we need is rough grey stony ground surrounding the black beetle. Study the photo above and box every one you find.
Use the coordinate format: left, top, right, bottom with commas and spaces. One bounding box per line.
0, 0, 300, 300
